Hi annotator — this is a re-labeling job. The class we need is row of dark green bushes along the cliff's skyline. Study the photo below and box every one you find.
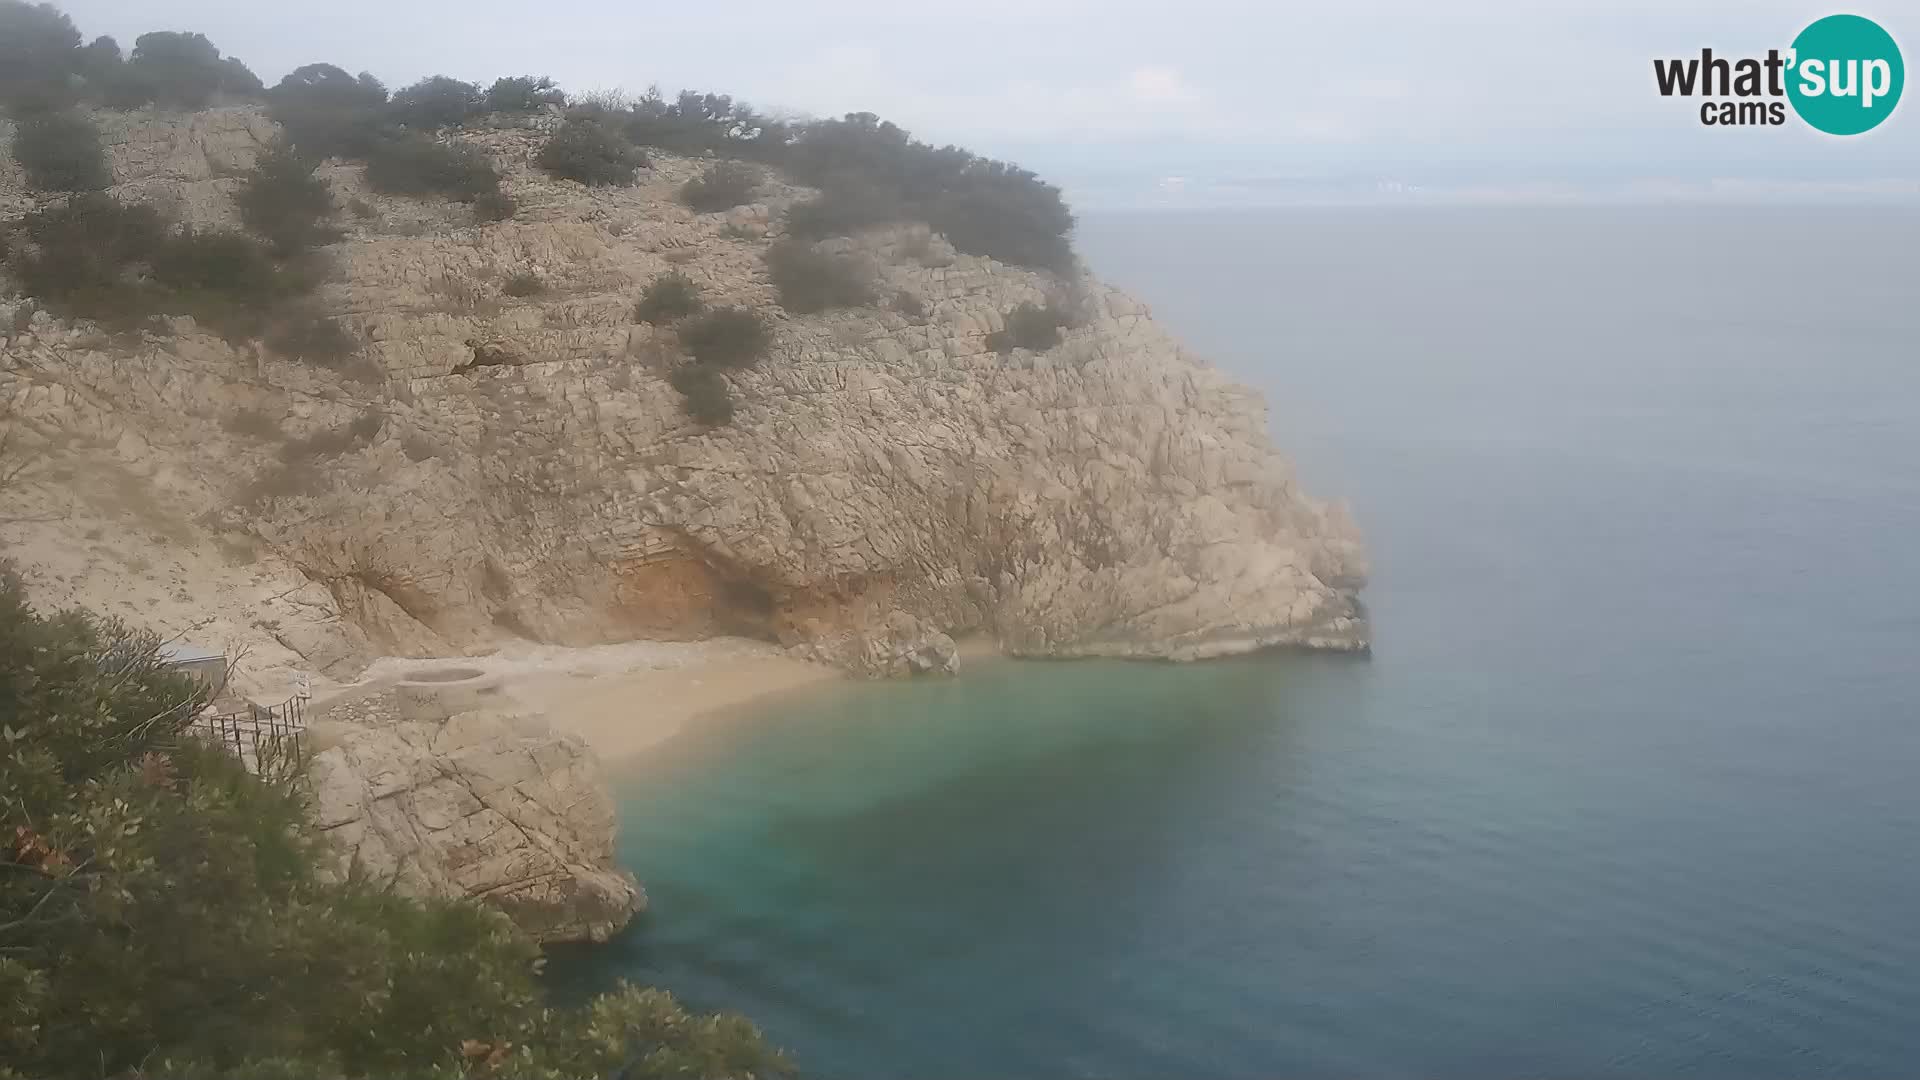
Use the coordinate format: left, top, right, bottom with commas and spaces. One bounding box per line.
0, 0, 1073, 273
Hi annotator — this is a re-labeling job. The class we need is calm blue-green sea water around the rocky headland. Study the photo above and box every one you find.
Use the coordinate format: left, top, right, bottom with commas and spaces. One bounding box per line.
561, 209, 1920, 1078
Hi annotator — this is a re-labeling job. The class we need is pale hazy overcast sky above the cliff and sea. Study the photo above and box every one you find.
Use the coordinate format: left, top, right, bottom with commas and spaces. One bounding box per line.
52, 0, 1920, 202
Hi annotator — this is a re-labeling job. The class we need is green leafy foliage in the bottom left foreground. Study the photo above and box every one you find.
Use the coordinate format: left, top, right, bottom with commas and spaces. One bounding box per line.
0, 569, 789, 1080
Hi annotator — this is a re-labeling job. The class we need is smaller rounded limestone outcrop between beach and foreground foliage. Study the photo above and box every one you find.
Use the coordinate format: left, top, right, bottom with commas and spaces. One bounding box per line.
309, 684, 645, 942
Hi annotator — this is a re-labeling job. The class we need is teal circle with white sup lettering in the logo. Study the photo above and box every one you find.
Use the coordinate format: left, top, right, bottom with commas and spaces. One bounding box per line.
1788, 15, 1907, 135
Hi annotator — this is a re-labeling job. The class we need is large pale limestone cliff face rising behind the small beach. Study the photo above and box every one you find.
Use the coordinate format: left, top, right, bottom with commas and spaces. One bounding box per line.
0, 108, 1367, 675
